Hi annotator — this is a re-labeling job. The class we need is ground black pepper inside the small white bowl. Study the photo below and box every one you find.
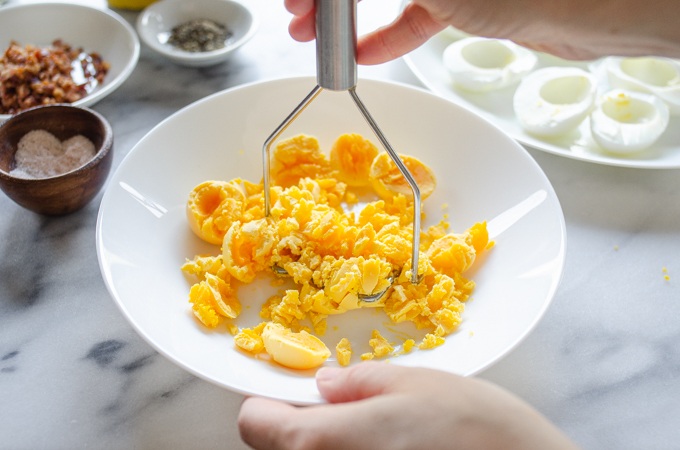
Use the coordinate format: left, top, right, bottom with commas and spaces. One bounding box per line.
168, 19, 231, 52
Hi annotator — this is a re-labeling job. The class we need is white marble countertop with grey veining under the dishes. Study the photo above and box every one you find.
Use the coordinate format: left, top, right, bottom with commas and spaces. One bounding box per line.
0, 0, 680, 449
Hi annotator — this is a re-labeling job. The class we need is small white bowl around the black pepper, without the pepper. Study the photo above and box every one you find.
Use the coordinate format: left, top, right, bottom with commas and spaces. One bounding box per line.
137, 0, 258, 67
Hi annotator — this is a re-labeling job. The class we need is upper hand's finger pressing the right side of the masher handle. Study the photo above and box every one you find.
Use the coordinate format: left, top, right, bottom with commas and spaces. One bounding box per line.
357, 3, 447, 65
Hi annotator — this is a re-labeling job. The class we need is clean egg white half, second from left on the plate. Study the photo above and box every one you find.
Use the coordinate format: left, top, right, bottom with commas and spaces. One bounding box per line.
513, 67, 597, 136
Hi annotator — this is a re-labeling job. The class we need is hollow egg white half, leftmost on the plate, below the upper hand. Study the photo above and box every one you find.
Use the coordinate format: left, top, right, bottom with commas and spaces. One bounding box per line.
442, 37, 537, 92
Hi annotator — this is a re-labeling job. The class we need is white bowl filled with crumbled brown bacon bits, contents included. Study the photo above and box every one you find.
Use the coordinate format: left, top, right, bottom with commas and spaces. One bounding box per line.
0, 2, 139, 123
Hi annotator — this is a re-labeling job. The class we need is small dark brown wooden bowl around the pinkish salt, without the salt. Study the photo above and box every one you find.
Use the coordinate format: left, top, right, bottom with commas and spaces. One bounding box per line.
0, 105, 113, 215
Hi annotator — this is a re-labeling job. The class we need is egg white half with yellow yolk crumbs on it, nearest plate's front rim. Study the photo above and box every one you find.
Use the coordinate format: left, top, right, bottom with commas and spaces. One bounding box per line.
590, 89, 669, 154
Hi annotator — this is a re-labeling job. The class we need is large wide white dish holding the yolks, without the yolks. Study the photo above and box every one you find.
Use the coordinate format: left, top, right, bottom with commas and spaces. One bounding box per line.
97, 77, 566, 404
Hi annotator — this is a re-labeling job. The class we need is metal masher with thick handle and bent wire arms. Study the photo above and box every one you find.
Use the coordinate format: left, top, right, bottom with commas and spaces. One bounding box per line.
262, 0, 421, 303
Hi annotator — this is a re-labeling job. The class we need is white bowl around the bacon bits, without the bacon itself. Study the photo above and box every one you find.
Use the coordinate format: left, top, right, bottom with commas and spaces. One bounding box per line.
0, 2, 139, 122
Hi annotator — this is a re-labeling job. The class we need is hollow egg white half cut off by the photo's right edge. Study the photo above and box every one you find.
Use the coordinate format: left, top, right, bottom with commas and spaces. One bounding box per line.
604, 56, 680, 116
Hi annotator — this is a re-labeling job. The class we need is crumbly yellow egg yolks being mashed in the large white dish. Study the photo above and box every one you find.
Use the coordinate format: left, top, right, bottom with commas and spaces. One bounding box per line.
182, 135, 489, 369
